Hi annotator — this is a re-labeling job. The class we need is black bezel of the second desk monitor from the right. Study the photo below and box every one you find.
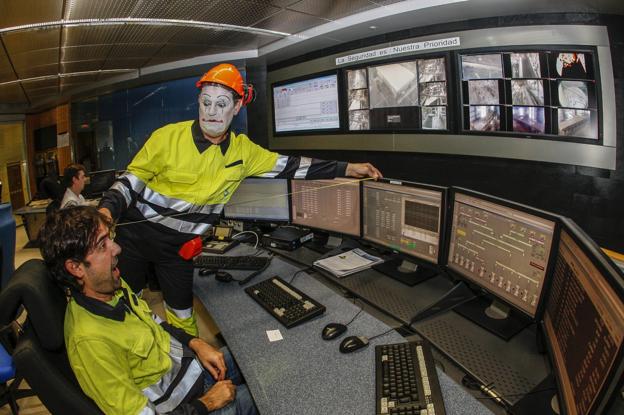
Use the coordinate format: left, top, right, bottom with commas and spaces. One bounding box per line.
445, 186, 561, 322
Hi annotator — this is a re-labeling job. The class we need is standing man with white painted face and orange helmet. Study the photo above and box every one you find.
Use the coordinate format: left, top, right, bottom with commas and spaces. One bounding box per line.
100, 64, 382, 335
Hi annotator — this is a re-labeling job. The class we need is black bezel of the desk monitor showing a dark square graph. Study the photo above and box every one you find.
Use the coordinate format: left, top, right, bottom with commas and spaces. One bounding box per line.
360, 178, 449, 266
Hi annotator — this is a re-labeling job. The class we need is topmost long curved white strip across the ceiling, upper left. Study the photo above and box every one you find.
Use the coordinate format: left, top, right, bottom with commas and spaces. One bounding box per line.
0, 17, 290, 37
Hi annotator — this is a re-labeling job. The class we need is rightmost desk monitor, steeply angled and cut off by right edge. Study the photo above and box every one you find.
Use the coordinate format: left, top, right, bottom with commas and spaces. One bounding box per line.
540, 218, 624, 415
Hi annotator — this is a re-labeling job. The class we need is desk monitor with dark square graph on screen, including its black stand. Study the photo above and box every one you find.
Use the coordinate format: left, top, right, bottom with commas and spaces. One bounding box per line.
362, 180, 446, 285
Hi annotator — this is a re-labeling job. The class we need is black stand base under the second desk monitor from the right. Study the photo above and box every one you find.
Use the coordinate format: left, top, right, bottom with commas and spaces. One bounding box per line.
454, 296, 531, 341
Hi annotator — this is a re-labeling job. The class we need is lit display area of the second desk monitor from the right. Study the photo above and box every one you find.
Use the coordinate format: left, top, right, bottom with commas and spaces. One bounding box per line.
448, 192, 555, 317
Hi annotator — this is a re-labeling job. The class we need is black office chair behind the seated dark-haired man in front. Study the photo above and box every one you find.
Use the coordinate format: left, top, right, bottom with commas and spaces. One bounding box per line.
0, 259, 102, 415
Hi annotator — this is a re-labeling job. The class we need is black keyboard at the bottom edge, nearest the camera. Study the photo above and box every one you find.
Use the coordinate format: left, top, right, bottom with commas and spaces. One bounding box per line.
375, 342, 445, 415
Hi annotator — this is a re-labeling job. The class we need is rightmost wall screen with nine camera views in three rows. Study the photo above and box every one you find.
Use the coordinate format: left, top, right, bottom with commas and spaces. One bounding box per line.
460, 51, 598, 142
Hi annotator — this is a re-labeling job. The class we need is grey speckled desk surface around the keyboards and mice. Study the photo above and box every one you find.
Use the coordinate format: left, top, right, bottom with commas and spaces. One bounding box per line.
194, 245, 492, 415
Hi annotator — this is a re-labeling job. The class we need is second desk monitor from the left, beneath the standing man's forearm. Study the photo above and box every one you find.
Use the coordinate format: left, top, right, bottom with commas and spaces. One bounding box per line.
290, 179, 360, 237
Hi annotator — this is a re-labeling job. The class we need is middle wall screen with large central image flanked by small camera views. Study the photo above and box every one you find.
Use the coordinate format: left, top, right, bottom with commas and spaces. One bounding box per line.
347, 57, 448, 131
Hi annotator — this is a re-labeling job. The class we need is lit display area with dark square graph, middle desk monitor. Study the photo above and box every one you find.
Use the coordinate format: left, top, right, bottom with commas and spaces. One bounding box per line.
362, 182, 442, 264
